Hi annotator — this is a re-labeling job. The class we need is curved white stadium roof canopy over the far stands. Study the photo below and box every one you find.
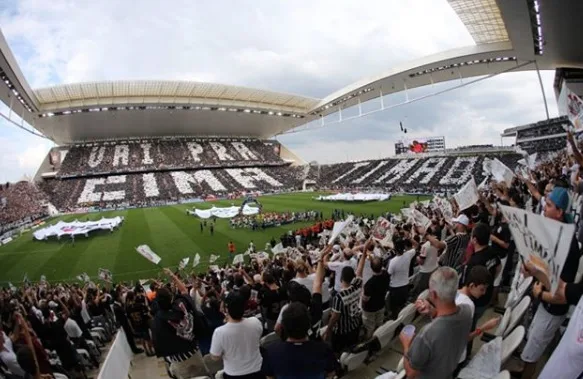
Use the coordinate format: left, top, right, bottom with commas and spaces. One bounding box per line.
0, 0, 583, 143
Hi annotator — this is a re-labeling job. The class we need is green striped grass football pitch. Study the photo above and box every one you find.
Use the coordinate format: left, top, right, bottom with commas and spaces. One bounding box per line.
0, 193, 428, 285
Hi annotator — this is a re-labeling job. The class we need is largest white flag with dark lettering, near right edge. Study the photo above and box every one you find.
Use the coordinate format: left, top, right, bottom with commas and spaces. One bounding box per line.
499, 205, 575, 293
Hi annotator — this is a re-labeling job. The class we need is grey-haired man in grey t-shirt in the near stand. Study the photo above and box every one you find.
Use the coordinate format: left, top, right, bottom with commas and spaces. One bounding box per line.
399, 267, 472, 379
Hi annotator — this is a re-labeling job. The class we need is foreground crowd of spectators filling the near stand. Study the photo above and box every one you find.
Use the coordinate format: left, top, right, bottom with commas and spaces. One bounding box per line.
0, 128, 583, 379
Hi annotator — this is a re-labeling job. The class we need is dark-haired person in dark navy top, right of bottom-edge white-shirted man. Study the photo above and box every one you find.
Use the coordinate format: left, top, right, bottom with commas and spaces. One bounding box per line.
262, 302, 338, 379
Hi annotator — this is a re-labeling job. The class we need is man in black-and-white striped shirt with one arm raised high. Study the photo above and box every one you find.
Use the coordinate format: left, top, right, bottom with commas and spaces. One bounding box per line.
322, 242, 367, 354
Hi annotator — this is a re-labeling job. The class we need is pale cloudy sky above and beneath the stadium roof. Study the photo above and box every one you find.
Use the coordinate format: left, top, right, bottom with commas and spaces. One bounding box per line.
0, 0, 557, 182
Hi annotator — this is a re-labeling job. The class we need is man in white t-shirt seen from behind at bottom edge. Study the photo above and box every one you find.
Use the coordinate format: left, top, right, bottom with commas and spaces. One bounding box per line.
210, 292, 265, 379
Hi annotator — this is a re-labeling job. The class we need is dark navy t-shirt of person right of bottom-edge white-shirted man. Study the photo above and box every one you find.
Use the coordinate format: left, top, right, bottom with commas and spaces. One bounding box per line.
261, 341, 338, 379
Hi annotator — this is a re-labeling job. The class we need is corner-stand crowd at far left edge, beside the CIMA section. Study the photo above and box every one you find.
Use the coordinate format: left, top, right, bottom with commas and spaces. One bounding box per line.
0, 181, 47, 236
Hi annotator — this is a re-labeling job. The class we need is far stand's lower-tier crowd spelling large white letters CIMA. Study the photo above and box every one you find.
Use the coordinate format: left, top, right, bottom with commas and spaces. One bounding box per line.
40, 166, 302, 212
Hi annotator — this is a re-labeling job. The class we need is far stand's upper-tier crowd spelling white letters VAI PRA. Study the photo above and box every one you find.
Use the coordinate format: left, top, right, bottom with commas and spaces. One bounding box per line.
57, 138, 285, 178
